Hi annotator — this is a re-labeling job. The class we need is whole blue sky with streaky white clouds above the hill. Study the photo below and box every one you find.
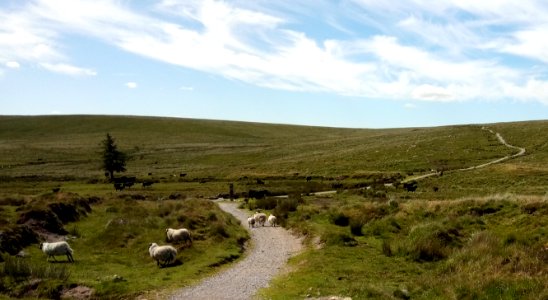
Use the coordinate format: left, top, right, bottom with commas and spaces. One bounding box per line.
0, 0, 548, 128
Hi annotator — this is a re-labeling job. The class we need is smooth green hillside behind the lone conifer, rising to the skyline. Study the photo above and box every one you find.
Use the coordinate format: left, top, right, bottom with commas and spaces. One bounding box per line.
0, 116, 548, 195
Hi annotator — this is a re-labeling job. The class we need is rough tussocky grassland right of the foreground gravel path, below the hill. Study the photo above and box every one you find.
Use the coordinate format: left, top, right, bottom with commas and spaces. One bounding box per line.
262, 194, 548, 299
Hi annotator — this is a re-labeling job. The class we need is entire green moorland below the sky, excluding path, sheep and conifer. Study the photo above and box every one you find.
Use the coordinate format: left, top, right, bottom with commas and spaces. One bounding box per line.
0, 116, 548, 299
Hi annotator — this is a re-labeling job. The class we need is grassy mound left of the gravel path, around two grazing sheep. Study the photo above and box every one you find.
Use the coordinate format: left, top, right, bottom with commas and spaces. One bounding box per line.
0, 193, 248, 299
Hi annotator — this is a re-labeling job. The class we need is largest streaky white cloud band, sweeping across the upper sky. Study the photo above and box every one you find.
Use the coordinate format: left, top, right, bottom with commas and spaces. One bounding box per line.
0, 0, 548, 104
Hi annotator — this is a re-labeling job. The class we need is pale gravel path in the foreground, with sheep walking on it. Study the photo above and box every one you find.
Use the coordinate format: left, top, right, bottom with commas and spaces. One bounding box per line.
169, 202, 302, 300
